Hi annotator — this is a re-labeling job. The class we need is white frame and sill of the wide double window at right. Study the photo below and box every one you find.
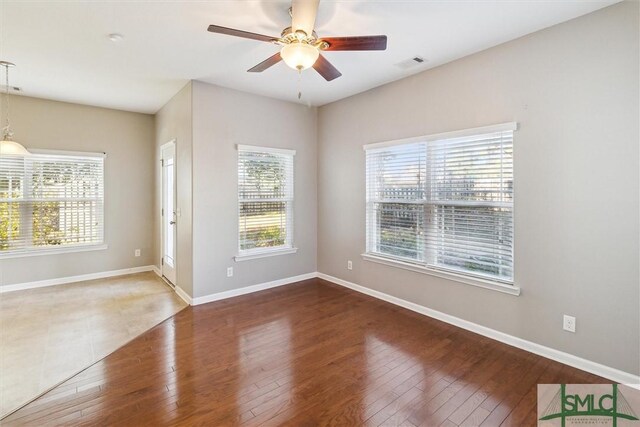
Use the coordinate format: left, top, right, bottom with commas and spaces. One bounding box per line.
361, 122, 520, 296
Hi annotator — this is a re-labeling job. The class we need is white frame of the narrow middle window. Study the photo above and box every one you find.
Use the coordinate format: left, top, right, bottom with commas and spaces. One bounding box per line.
234, 144, 298, 262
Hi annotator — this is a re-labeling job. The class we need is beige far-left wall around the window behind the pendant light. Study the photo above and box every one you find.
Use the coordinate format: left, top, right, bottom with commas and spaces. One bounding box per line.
0, 96, 154, 286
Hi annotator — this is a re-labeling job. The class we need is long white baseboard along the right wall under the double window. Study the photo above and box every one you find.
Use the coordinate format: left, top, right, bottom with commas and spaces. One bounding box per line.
317, 273, 640, 388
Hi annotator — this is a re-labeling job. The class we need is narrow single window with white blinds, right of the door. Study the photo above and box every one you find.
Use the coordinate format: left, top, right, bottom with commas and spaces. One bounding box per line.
236, 145, 295, 260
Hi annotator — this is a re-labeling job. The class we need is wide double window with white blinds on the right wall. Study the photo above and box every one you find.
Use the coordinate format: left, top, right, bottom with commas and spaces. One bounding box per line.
365, 124, 515, 284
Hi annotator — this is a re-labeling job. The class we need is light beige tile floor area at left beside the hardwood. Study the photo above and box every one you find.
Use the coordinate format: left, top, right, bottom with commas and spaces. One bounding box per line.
0, 272, 186, 418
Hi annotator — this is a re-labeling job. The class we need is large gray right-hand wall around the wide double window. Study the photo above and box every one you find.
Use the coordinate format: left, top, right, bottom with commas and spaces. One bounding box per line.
318, 2, 640, 374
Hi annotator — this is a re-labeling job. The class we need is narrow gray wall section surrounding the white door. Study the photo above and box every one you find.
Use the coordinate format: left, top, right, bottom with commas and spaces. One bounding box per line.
153, 82, 193, 296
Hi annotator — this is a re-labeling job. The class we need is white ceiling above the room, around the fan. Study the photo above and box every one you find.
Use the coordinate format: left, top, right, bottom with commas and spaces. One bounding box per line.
0, 0, 618, 113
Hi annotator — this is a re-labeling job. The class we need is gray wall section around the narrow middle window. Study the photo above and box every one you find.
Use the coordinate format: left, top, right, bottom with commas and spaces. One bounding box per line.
193, 82, 317, 297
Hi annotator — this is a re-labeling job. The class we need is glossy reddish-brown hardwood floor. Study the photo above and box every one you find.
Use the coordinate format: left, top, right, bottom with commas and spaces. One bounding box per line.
2, 279, 610, 426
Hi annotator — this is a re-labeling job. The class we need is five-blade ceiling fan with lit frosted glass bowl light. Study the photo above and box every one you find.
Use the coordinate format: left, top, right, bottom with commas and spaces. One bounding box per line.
208, 0, 387, 81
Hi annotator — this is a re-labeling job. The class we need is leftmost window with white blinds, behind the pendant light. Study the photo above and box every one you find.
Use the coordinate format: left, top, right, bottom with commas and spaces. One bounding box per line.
0, 152, 104, 257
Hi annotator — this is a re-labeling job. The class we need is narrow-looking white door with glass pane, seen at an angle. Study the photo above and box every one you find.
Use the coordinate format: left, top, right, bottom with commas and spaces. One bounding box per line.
160, 141, 177, 285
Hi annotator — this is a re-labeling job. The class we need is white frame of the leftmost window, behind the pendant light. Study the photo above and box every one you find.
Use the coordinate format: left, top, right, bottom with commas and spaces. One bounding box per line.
0, 149, 109, 260
